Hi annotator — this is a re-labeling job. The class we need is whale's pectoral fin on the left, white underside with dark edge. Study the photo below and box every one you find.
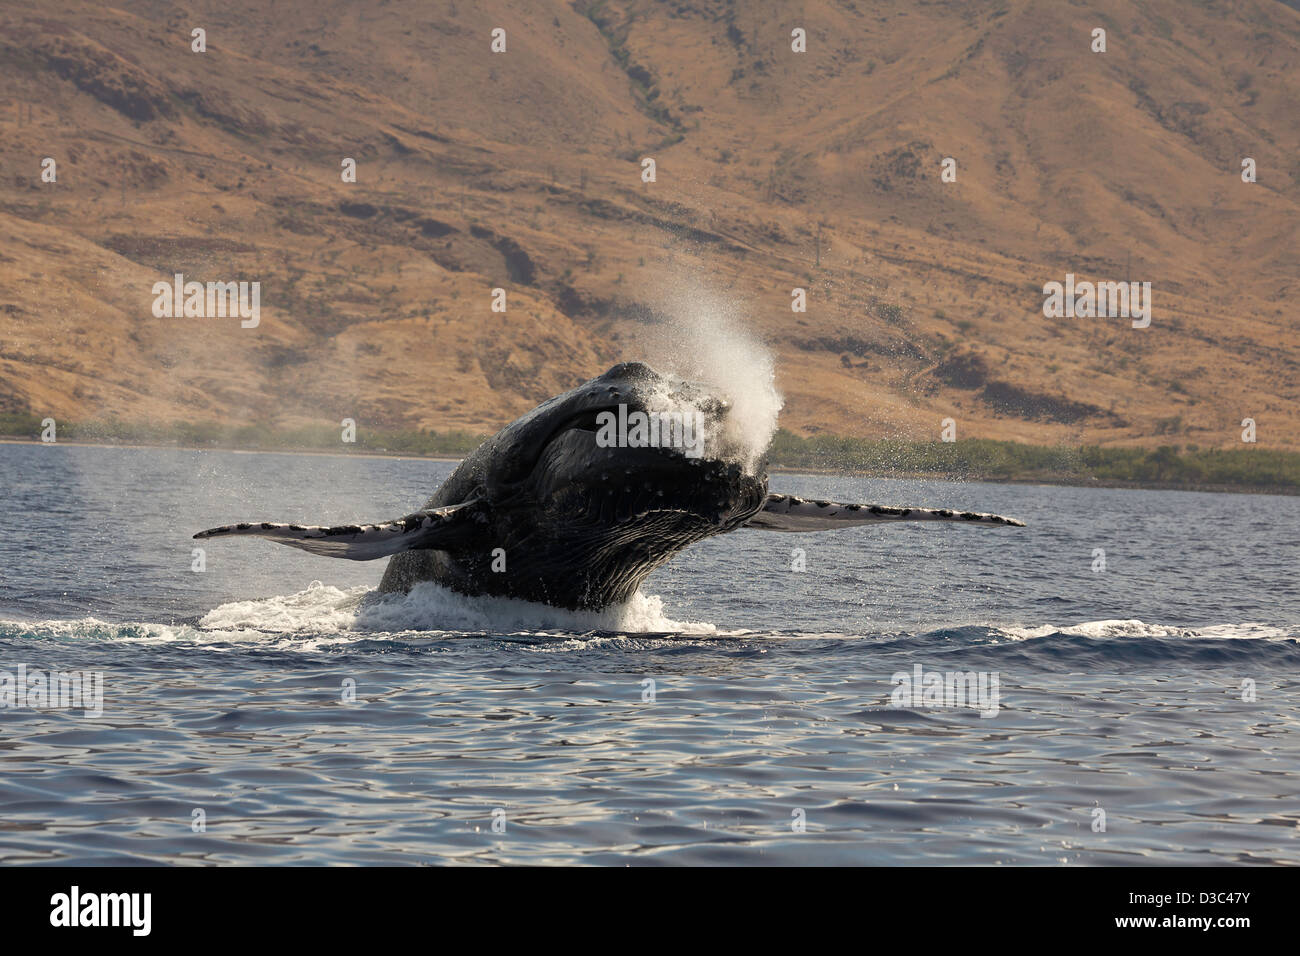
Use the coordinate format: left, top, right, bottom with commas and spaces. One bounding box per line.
195, 499, 482, 561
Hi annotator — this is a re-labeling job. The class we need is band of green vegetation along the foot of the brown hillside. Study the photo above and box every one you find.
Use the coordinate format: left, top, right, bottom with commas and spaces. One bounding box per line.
0, 414, 1300, 494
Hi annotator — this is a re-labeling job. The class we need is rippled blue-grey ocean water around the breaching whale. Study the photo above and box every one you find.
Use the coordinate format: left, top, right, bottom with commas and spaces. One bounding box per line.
0, 445, 1300, 865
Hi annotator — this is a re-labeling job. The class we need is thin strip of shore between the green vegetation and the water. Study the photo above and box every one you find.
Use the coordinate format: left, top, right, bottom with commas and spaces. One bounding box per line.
0, 434, 1300, 496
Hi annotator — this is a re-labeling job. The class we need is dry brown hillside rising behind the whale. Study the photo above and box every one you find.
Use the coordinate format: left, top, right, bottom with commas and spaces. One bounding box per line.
0, 0, 1300, 449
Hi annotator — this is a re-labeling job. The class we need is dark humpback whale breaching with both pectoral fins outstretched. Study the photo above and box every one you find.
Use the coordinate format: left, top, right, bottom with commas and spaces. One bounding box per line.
194, 362, 1023, 610
